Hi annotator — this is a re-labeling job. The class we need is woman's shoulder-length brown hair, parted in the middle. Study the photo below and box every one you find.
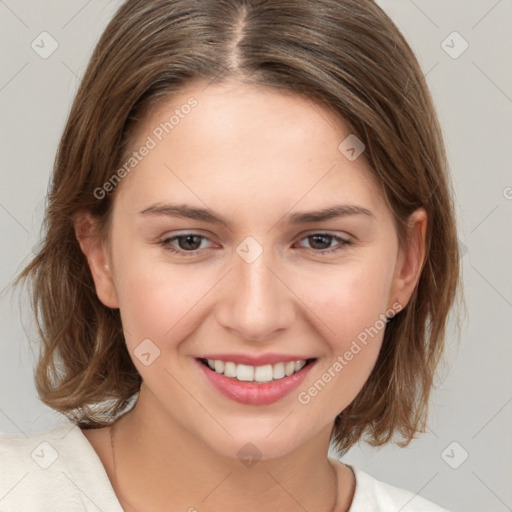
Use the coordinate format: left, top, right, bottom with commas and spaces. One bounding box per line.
15, 0, 460, 452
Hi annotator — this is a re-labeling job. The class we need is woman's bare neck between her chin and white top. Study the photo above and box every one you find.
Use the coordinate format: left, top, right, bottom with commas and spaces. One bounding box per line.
111, 388, 350, 512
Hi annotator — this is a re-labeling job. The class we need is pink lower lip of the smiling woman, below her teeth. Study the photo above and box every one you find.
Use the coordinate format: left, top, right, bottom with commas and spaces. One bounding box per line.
196, 359, 315, 405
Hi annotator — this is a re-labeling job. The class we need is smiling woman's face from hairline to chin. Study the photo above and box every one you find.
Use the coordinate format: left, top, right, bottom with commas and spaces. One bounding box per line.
83, 82, 424, 458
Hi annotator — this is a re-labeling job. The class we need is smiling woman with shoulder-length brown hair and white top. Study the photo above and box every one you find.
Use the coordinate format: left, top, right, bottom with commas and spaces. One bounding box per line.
0, 0, 459, 512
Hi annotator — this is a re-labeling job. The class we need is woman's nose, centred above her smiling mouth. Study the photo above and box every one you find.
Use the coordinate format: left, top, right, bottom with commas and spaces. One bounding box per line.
217, 242, 295, 342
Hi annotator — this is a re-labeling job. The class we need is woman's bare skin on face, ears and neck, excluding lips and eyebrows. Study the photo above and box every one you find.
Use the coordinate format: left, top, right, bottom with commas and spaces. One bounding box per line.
76, 80, 427, 512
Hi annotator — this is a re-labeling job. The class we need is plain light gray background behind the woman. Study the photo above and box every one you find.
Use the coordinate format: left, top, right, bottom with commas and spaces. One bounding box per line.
0, 0, 512, 512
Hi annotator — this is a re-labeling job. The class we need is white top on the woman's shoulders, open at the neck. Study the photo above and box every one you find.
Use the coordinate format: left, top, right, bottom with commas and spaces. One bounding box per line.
0, 423, 448, 512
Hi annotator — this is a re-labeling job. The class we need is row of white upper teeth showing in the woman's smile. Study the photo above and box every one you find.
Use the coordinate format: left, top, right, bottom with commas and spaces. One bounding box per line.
203, 359, 306, 382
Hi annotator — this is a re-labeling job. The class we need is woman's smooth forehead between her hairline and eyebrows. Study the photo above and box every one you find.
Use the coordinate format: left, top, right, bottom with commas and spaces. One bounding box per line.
113, 81, 384, 222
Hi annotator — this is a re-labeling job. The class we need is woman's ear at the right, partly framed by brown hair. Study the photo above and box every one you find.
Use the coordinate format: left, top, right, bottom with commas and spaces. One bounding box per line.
388, 208, 428, 309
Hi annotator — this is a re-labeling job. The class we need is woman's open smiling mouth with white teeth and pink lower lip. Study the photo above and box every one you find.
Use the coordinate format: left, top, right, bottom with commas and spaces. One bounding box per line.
195, 358, 317, 405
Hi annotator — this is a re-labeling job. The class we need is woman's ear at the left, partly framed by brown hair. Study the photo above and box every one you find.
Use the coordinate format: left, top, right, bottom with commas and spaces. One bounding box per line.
73, 212, 119, 308
